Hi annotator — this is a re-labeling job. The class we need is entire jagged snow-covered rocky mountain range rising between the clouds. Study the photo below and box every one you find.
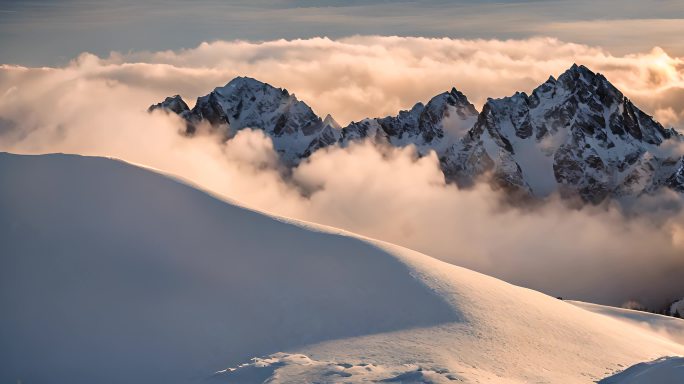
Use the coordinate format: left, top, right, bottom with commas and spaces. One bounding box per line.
150, 65, 684, 202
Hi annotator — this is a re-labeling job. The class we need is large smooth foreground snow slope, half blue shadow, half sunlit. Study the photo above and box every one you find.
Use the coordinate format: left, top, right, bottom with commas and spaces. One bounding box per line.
0, 154, 684, 384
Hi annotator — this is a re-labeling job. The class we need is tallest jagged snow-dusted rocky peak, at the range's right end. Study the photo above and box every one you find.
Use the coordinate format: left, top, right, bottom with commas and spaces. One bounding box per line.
443, 64, 679, 202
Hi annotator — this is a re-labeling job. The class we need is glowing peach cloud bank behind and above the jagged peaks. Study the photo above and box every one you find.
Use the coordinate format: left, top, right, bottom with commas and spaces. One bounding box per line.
95, 36, 684, 126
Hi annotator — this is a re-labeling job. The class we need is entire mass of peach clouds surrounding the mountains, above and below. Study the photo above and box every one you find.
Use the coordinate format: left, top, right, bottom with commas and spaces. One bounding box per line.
0, 37, 684, 306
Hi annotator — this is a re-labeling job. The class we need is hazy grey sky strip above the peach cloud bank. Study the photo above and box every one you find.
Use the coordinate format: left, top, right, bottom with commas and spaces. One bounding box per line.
0, 0, 684, 66
